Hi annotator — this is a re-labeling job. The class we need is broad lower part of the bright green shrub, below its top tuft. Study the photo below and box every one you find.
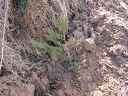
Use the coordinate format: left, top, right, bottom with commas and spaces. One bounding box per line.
32, 29, 64, 60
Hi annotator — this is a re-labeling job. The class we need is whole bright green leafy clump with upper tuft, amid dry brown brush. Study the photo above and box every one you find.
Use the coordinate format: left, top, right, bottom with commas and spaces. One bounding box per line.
32, 16, 67, 60
